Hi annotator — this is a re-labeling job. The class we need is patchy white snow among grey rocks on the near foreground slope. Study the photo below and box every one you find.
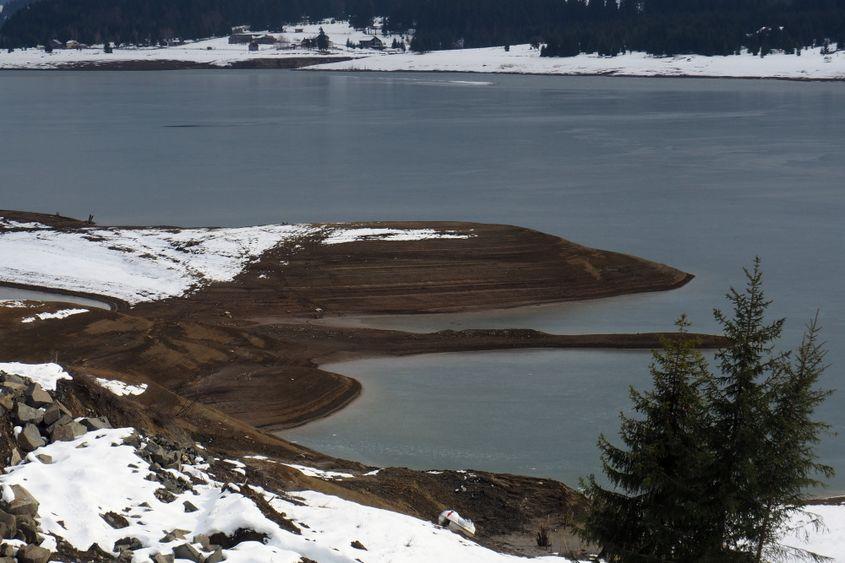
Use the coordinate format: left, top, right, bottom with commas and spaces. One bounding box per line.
0, 420, 566, 563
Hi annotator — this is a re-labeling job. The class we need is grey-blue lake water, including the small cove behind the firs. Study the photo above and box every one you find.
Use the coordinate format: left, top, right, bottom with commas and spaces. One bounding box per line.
0, 71, 845, 490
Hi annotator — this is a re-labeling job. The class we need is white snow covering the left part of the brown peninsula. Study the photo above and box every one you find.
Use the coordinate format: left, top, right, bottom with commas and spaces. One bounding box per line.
0, 223, 465, 306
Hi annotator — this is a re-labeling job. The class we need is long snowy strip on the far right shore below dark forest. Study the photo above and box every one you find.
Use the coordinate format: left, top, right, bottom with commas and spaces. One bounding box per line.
308, 45, 845, 80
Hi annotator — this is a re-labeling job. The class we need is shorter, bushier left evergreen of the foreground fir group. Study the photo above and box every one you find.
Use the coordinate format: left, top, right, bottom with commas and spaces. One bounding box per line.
583, 317, 712, 562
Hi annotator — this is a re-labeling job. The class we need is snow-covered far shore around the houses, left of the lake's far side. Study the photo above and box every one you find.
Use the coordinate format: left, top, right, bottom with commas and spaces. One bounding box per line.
0, 22, 405, 69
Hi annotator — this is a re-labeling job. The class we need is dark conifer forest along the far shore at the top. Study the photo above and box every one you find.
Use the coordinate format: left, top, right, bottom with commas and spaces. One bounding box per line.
0, 0, 845, 56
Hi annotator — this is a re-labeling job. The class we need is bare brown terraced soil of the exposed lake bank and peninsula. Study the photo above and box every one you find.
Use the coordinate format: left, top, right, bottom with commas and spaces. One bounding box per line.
0, 211, 720, 553
